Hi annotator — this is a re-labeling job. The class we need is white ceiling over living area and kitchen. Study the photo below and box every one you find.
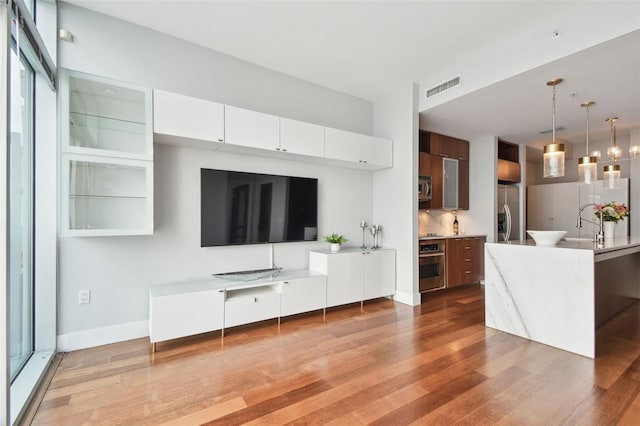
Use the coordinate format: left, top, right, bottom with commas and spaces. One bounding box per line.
61, 0, 640, 143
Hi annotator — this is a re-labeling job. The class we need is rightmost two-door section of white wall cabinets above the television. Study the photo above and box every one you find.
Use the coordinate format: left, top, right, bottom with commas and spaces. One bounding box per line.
324, 127, 393, 170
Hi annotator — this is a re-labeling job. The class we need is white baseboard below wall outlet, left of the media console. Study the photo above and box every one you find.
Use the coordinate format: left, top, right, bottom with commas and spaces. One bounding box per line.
57, 320, 149, 352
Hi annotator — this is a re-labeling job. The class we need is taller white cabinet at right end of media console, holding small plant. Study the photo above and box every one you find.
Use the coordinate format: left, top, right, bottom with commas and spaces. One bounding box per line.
309, 249, 396, 307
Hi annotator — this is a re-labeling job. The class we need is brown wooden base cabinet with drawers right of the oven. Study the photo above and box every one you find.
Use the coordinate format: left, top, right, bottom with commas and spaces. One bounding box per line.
445, 237, 485, 288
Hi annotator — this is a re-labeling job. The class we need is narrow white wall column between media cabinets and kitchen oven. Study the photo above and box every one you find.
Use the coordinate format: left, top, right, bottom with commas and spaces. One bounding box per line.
373, 83, 420, 305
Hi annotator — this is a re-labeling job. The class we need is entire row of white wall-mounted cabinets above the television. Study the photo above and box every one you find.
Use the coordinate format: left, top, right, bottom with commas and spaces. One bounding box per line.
154, 89, 393, 170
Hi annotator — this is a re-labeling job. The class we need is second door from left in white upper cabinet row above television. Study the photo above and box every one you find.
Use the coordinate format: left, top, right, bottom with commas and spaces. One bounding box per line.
224, 105, 280, 151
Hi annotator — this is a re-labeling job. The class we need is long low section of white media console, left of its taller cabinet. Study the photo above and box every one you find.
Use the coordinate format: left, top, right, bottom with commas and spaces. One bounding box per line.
149, 271, 327, 350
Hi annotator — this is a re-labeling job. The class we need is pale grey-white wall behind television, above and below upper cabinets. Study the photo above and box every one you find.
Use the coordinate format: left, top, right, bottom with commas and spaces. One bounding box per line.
58, 3, 384, 350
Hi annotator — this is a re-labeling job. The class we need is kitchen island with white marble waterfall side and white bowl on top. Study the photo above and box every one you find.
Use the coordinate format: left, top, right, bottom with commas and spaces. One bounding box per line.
484, 238, 640, 358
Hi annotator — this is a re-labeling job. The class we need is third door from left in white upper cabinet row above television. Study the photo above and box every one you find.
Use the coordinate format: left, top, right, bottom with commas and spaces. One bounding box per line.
280, 118, 324, 157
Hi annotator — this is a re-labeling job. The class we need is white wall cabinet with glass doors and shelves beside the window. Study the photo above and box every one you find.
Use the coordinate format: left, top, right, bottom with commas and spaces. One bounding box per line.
59, 70, 153, 236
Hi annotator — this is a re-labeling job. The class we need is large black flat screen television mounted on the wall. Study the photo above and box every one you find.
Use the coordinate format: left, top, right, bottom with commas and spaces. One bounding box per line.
200, 169, 318, 247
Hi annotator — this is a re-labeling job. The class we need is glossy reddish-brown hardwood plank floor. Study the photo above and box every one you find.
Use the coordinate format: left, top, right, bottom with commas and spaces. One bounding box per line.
33, 287, 640, 425
